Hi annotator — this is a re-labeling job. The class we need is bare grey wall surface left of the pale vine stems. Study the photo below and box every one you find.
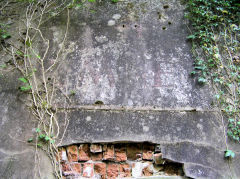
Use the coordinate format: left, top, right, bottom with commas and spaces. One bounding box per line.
0, 73, 53, 179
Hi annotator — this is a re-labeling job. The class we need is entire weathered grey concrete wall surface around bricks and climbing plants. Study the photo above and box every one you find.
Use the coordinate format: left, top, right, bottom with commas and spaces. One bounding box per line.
0, 0, 240, 179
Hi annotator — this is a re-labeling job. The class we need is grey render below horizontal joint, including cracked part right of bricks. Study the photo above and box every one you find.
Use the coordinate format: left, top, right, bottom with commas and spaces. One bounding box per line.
59, 110, 239, 179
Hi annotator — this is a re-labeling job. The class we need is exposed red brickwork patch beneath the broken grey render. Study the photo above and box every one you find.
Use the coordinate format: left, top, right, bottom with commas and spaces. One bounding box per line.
58, 143, 183, 179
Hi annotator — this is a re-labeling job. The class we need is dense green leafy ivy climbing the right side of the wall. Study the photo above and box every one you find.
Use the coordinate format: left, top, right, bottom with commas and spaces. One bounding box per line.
185, 0, 240, 152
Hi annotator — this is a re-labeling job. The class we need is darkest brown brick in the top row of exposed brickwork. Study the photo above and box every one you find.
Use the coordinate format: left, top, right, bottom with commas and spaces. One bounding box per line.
127, 144, 142, 160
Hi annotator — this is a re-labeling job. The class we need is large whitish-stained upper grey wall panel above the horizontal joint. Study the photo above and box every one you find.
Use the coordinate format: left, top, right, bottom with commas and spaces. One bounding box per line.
53, 0, 212, 108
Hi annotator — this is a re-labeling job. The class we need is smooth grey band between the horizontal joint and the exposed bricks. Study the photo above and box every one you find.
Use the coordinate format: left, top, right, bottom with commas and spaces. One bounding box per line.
60, 110, 225, 148
